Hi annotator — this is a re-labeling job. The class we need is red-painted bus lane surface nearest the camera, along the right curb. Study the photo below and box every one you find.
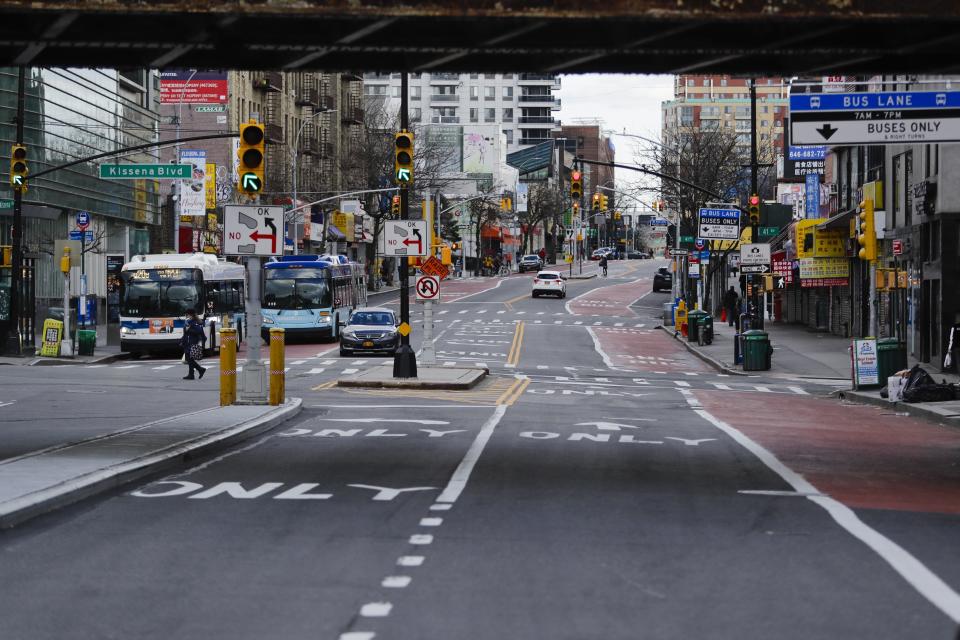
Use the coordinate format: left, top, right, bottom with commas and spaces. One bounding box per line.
694, 390, 960, 514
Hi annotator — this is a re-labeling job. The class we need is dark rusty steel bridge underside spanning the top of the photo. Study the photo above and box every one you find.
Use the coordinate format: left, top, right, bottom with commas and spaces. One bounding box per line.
0, 0, 960, 76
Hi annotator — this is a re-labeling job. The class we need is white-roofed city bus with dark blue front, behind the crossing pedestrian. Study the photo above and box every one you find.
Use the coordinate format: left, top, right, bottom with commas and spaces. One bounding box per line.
120, 253, 245, 357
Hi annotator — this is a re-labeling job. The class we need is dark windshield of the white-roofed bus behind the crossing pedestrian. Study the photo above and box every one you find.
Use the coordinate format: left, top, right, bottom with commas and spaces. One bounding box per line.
120, 270, 202, 318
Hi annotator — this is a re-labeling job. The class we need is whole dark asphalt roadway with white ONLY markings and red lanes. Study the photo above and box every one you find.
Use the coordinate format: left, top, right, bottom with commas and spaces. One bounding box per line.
0, 261, 960, 640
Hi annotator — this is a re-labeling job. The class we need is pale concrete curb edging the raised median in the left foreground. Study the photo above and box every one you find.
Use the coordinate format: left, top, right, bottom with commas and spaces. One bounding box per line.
0, 398, 303, 529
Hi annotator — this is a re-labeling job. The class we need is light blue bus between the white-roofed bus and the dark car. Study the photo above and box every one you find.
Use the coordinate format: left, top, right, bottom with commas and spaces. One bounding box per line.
261, 255, 367, 340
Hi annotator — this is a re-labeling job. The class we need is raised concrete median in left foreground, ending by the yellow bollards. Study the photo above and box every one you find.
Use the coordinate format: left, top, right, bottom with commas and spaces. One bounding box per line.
0, 398, 301, 527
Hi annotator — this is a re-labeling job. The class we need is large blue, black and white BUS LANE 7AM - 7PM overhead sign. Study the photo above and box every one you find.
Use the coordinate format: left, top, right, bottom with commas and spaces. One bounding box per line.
790, 91, 960, 145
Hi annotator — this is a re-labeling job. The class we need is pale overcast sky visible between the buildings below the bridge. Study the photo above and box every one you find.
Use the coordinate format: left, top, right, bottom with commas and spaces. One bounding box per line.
557, 74, 673, 198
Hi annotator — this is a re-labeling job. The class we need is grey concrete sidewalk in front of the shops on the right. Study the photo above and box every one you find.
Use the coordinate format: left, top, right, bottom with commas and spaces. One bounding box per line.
661, 322, 960, 426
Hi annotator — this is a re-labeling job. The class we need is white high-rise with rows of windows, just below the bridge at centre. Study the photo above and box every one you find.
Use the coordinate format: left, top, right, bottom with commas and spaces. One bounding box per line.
363, 73, 560, 152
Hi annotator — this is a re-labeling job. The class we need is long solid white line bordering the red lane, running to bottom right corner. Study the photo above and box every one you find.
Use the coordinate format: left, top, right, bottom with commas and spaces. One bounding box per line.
684, 392, 960, 624
